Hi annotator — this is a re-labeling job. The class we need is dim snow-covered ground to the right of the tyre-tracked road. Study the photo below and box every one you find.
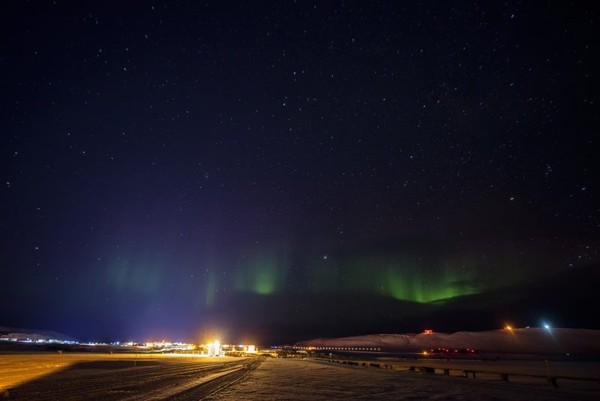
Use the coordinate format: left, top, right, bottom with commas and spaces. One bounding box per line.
210, 359, 600, 401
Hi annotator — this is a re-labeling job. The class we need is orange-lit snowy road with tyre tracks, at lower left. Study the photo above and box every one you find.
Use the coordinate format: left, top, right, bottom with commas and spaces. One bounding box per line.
0, 354, 261, 401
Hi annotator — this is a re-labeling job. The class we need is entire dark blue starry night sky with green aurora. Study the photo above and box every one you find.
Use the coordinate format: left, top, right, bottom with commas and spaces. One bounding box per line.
0, 0, 600, 343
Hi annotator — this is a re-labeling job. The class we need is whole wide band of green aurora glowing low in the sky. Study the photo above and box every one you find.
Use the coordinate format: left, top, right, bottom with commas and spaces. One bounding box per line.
106, 247, 502, 309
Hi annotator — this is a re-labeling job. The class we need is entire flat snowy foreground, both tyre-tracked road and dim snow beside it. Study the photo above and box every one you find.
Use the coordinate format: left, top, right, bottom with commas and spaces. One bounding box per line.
0, 353, 600, 401
